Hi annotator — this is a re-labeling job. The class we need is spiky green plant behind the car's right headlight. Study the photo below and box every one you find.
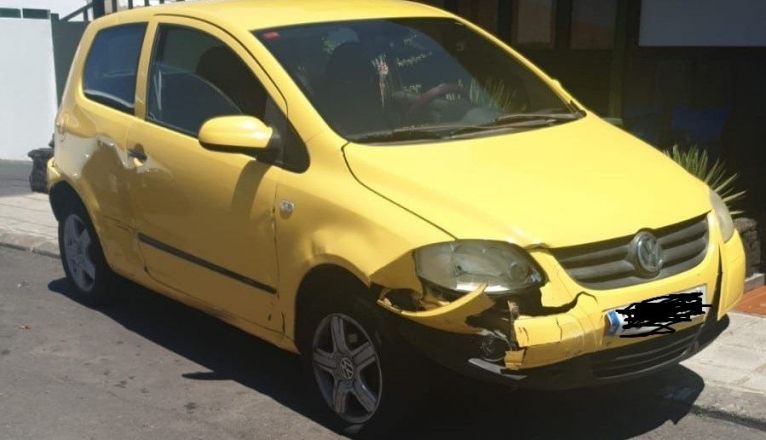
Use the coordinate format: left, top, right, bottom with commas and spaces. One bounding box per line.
664, 145, 745, 216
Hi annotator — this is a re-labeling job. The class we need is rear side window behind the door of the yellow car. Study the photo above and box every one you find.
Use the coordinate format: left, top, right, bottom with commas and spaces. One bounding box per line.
83, 24, 146, 114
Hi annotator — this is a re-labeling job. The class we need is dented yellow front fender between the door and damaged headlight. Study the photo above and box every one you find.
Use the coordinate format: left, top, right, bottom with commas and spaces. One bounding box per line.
276, 131, 452, 344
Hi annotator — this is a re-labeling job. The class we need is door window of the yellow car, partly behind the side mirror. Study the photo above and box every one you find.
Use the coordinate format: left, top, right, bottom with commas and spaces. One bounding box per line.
147, 25, 309, 172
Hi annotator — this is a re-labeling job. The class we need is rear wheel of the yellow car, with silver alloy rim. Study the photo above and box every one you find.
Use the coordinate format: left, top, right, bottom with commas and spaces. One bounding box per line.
58, 200, 115, 306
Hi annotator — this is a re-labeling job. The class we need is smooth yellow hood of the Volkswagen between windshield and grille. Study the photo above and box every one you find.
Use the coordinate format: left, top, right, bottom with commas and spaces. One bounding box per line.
344, 116, 710, 247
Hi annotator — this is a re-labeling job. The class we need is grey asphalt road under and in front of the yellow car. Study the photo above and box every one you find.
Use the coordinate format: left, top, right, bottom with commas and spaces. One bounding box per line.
0, 248, 764, 440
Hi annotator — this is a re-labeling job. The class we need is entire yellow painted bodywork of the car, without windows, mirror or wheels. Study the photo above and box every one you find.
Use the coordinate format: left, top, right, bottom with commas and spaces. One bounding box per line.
48, 0, 744, 382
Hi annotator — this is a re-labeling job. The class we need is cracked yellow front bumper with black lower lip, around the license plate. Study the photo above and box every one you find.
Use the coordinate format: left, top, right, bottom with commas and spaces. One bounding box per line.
380, 220, 744, 388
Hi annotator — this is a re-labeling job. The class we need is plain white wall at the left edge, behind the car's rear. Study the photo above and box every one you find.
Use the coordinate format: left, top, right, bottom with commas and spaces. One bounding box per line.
0, 18, 56, 159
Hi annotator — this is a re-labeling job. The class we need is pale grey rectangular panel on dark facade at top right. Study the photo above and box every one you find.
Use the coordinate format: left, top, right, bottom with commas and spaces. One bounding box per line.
639, 0, 766, 46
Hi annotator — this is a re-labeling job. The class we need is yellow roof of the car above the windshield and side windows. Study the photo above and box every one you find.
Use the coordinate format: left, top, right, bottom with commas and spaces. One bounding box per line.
115, 0, 451, 31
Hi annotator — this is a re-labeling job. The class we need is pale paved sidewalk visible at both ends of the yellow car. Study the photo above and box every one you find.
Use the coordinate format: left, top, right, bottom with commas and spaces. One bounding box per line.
0, 188, 766, 430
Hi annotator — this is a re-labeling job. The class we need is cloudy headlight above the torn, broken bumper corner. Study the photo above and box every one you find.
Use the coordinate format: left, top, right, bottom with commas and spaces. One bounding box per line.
415, 240, 543, 295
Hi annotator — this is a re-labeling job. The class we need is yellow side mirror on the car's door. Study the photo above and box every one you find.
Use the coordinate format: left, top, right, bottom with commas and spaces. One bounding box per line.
199, 116, 274, 155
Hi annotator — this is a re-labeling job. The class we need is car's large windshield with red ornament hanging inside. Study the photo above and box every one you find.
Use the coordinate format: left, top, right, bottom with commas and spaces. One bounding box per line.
255, 18, 580, 143
